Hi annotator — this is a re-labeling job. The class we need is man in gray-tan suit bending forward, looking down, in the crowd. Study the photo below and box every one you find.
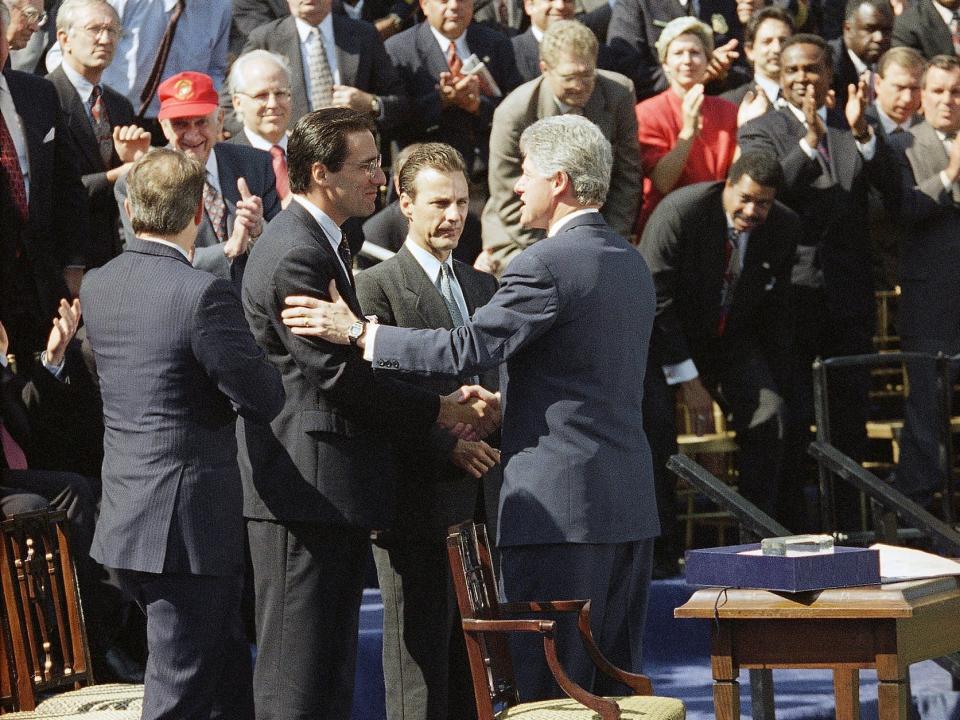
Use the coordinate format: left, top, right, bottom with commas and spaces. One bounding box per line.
482, 20, 643, 272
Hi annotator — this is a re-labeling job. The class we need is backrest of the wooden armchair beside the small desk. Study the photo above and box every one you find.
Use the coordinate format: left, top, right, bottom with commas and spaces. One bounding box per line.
447, 522, 520, 720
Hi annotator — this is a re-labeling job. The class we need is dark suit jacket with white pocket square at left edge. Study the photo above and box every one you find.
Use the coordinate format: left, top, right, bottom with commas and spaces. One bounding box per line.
0, 70, 89, 323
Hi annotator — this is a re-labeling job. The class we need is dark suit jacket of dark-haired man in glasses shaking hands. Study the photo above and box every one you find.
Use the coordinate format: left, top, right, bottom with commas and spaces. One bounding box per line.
241, 200, 439, 529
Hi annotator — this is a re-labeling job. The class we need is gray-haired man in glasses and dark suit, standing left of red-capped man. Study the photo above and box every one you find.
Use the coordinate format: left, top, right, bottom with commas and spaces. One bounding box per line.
47, 0, 133, 267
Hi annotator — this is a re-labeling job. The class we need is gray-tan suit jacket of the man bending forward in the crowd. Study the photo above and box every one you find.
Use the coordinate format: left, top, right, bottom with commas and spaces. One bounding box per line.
482, 70, 643, 262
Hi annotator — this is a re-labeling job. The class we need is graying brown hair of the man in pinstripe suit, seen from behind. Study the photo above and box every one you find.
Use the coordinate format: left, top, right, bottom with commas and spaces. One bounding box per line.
127, 148, 206, 237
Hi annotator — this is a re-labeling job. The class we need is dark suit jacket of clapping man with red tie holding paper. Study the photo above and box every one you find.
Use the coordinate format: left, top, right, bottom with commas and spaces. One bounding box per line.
386, 22, 520, 167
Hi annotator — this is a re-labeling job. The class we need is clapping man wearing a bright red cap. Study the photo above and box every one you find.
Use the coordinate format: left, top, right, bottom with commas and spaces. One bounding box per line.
115, 72, 280, 282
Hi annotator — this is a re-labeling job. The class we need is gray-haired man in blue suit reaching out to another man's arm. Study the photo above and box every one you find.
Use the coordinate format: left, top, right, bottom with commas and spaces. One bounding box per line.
283, 115, 660, 700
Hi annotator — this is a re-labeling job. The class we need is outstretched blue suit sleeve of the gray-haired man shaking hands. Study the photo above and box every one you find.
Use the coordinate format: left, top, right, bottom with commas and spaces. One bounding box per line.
373, 250, 561, 375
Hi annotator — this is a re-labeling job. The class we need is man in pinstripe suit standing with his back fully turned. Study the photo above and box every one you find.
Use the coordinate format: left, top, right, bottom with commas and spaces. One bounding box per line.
81, 149, 284, 720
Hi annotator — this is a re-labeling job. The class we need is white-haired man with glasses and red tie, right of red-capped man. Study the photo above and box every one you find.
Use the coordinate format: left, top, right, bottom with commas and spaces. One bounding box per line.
229, 50, 293, 207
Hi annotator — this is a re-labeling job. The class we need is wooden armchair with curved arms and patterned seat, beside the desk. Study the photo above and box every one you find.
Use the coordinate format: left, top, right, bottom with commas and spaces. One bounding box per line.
447, 522, 685, 720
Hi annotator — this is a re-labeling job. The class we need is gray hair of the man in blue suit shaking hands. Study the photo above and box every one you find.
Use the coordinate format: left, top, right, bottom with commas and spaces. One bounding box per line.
520, 115, 613, 205
